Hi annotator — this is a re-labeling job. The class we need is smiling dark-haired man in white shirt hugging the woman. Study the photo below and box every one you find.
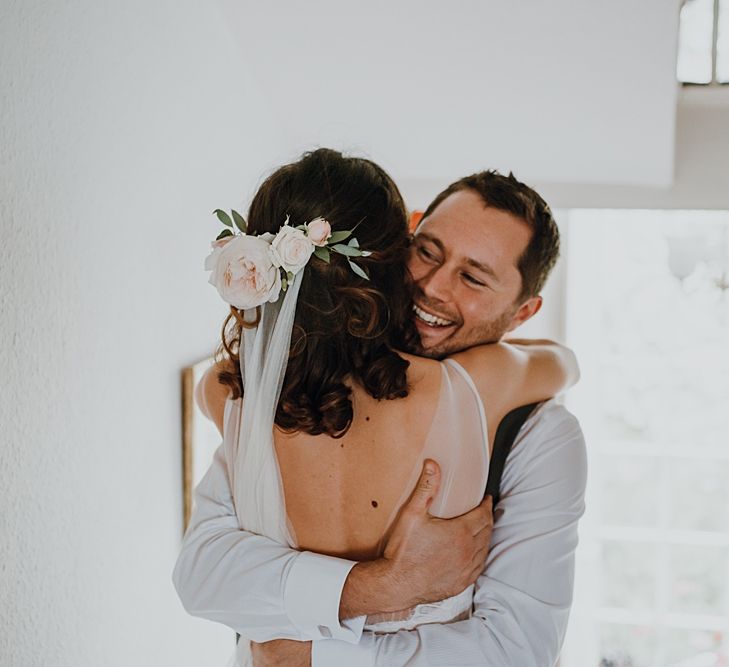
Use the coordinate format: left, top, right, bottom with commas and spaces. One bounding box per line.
175, 172, 586, 667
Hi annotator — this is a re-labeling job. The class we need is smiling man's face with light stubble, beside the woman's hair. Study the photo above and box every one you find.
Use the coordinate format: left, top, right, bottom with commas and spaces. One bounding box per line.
408, 190, 541, 358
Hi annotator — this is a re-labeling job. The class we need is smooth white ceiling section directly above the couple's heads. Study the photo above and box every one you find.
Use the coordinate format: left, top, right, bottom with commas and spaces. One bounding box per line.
219, 0, 679, 187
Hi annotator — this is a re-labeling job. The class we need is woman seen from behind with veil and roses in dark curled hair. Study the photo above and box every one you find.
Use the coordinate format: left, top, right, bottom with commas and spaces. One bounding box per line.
176, 150, 576, 664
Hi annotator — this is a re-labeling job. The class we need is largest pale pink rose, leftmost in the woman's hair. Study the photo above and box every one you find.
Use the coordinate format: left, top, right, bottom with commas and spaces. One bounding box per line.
205, 234, 281, 310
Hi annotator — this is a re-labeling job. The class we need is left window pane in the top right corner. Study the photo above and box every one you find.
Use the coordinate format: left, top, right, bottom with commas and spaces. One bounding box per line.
677, 0, 726, 83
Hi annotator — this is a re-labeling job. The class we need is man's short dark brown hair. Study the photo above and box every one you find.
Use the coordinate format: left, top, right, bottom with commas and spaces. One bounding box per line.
423, 170, 559, 302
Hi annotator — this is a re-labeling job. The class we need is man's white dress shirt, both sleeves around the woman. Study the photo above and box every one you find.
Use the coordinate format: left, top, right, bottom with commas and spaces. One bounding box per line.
173, 400, 587, 667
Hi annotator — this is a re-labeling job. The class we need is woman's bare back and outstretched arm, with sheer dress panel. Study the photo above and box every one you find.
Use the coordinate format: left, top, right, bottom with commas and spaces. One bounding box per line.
200, 342, 576, 559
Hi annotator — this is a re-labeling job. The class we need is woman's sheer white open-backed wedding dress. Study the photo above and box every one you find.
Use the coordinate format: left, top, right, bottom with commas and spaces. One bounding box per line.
223, 359, 489, 667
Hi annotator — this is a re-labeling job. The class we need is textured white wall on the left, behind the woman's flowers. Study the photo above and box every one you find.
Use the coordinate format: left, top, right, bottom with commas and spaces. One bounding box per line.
0, 0, 290, 667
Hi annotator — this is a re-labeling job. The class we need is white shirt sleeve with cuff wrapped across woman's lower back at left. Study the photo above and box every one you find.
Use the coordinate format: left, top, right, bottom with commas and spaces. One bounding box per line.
172, 446, 365, 644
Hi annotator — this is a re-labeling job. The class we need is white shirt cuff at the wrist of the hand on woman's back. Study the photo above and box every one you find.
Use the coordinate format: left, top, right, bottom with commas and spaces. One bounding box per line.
284, 551, 366, 644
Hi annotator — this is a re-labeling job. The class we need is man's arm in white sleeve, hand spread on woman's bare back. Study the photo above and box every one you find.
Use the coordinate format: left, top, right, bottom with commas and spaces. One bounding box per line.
173, 447, 491, 643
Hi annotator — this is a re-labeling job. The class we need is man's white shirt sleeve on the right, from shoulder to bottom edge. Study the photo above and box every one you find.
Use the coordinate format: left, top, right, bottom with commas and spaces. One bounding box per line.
312, 401, 587, 667
